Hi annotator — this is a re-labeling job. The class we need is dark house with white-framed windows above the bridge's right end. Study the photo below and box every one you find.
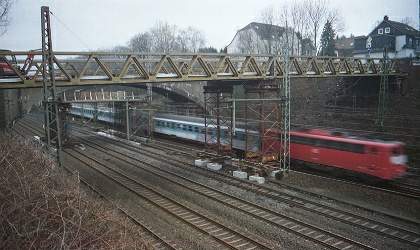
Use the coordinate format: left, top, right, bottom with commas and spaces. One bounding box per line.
353, 16, 420, 58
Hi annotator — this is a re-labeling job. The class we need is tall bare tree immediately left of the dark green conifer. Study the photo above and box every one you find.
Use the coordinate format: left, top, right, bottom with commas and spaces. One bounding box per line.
305, 0, 328, 53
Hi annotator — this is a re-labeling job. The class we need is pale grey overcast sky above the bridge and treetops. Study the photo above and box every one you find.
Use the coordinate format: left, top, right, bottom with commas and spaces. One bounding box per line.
0, 0, 419, 51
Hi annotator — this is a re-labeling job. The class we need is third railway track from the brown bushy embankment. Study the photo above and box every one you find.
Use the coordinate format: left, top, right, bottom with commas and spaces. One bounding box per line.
73, 134, 372, 249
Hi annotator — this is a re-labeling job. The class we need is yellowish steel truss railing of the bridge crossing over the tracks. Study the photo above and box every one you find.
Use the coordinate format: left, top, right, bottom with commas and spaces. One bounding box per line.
0, 51, 400, 88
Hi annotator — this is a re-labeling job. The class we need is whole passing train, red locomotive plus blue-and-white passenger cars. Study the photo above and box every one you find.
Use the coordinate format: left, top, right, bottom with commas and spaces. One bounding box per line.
70, 105, 408, 180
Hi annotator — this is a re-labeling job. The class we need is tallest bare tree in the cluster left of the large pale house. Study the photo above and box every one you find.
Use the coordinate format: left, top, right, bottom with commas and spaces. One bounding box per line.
150, 22, 179, 53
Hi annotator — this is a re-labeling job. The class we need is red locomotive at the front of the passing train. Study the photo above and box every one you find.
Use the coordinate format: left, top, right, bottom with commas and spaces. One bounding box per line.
262, 129, 407, 180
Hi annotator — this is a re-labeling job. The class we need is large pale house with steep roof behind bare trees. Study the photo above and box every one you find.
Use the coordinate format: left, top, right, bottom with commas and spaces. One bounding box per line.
226, 22, 315, 55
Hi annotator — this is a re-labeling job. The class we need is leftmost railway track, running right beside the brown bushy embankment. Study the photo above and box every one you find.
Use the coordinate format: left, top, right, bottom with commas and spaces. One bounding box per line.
10, 122, 176, 250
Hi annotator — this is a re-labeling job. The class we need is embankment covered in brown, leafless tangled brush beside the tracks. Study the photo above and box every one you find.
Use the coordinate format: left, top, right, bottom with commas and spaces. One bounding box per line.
0, 135, 150, 249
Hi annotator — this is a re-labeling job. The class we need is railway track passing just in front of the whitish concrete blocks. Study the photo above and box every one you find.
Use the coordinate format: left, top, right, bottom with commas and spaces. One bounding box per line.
16, 117, 420, 246
